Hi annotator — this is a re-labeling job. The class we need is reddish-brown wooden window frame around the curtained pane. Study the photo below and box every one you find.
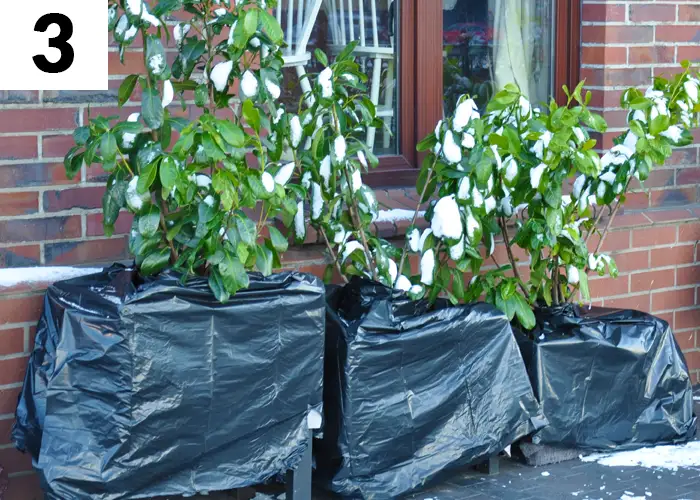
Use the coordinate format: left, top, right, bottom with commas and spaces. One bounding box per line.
365, 0, 581, 188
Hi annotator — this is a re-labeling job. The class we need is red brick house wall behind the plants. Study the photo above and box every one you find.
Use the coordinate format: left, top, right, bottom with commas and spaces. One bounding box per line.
0, 0, 700, 500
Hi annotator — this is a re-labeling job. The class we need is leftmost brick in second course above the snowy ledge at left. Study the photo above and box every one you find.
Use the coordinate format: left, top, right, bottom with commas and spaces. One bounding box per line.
0, 215, 82, 243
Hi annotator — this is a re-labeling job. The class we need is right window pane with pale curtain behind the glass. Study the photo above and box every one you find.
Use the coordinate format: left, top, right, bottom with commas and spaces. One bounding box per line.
443, 0, 554, 113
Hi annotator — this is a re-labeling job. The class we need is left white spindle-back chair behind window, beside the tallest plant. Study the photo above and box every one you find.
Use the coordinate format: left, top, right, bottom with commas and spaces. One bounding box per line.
276, 0, 323, 104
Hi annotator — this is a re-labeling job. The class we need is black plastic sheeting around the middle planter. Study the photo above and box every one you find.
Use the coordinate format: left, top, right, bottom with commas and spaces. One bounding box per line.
315, 279, 544, 499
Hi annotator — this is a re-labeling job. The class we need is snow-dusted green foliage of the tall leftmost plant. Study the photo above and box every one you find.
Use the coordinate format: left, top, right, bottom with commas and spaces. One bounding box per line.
71, 0, 304, 301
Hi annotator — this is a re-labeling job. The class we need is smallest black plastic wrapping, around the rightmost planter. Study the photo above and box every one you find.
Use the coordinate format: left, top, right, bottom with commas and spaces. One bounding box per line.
516, 305, 696, 451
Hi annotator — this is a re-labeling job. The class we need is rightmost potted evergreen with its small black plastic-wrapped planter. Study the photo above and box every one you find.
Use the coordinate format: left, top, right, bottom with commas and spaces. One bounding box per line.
416, 63, 700, 449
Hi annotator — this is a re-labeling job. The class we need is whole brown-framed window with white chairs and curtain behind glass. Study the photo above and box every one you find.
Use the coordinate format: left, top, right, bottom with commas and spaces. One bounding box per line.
277, 0, 581, 187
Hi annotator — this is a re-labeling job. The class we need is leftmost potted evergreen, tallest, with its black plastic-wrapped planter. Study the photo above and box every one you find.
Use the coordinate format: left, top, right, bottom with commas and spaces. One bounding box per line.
13, 0, 325, 499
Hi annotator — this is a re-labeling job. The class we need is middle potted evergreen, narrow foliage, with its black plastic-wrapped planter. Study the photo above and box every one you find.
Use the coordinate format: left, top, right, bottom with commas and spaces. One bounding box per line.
293, 44, 543, 498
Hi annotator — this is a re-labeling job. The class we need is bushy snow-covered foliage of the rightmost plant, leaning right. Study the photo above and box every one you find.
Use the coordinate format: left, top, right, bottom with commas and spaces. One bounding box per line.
407, 65, 700, 328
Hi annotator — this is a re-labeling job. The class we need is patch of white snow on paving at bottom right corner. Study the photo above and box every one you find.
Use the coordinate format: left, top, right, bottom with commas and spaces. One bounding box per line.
581, 441, 700, 471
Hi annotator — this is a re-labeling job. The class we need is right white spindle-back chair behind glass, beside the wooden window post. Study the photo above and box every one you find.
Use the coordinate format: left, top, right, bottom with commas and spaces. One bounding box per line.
323, 0, 396, 148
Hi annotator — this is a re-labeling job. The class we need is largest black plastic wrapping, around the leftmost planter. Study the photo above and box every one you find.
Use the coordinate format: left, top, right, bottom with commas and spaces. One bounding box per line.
12, 266, 325, 500
